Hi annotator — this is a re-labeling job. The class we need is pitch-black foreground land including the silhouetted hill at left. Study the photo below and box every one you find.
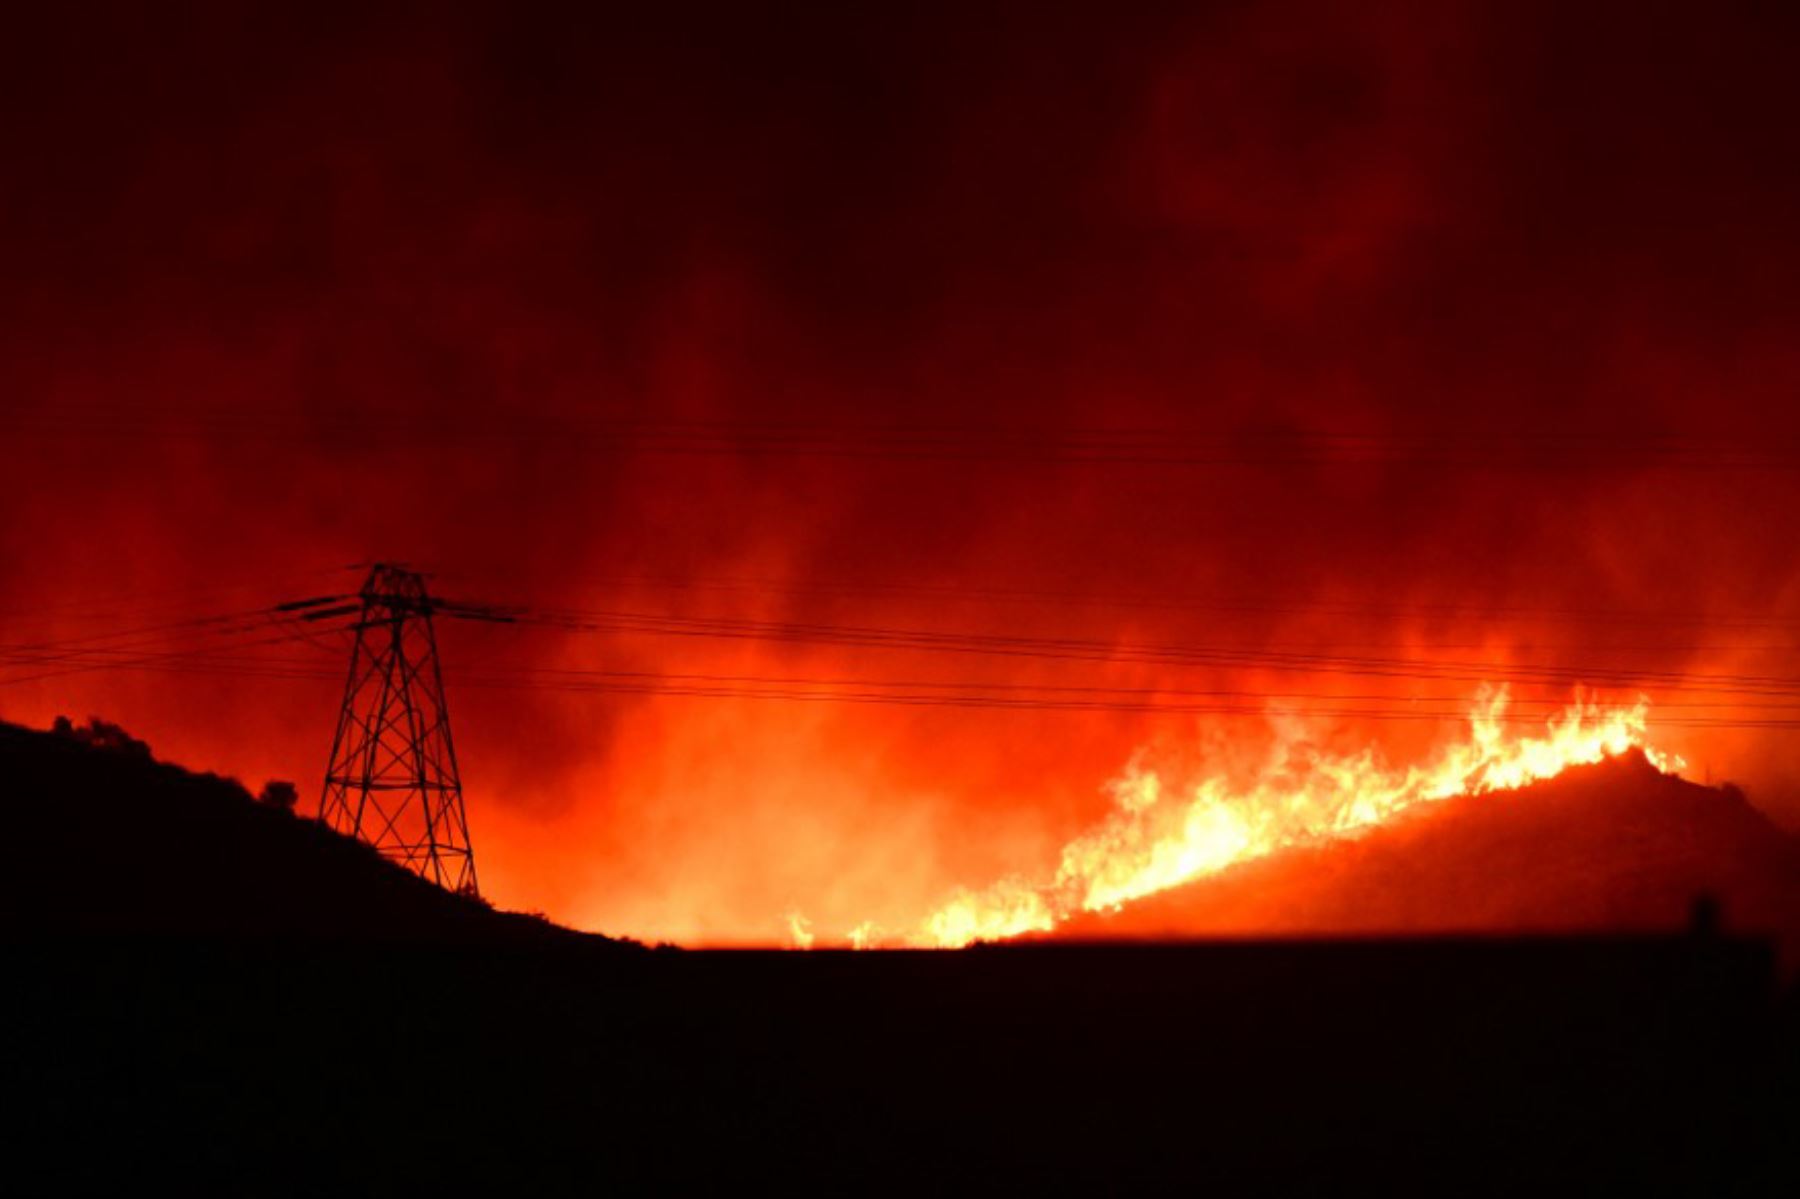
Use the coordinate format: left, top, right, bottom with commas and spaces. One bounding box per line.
0, 720, 1800, 1194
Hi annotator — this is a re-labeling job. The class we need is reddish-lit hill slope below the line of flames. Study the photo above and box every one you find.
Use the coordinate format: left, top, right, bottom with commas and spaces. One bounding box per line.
1062, 754, 1800, 954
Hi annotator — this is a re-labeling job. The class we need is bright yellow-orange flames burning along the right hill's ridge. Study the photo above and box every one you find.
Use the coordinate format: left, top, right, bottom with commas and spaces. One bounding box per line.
907, 688, 1685, 947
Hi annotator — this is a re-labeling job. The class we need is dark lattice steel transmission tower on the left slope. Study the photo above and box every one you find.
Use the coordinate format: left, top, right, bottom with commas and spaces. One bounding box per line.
319, 563, 481, 895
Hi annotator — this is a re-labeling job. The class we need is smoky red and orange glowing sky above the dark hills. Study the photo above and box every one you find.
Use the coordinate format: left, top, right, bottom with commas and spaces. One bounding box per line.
0, 4, 1800, 940
